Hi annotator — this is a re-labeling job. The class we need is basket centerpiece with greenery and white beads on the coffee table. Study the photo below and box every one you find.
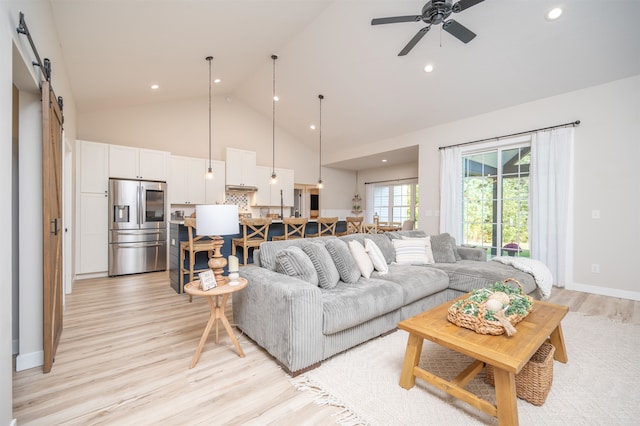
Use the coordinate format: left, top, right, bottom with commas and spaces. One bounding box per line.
447, 278, 533, 336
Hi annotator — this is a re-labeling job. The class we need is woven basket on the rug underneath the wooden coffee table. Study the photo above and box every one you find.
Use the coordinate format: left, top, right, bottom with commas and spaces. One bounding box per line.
485, 343, 556, 406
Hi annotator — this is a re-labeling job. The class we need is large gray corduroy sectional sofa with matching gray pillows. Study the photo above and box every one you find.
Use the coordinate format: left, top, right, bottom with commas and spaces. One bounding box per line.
233, 230, 536, 375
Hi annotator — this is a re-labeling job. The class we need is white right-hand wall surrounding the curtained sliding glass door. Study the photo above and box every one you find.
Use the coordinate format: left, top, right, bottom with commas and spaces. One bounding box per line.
368, 76, 640, 300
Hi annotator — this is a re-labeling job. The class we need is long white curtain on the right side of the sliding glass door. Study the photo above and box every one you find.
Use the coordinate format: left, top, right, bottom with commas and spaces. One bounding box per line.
529, 127, 574, 287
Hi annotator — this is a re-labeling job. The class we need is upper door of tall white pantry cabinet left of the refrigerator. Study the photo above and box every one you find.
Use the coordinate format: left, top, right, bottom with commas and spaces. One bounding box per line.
77, 141, 109, 194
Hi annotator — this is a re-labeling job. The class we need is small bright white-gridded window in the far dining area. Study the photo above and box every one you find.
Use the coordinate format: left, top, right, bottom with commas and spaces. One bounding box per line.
368, 181, 418, 227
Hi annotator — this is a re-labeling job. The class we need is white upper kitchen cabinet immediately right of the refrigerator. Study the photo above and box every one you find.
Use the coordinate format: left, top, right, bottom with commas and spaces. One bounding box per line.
167, 155, 207, 204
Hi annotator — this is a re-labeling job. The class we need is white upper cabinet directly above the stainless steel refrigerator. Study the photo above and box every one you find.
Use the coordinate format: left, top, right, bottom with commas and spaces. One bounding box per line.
109, 145, 170, 181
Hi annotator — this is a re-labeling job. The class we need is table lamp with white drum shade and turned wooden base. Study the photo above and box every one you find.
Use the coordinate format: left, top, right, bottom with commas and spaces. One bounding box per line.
196, 204, 240, 285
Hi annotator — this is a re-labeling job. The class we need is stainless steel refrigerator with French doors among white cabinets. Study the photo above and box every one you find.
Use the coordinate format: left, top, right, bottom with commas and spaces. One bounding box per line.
109, 179, 167, 276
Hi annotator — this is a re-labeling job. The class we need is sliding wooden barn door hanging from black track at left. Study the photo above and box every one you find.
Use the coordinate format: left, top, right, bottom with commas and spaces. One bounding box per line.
41, 81, 63, 373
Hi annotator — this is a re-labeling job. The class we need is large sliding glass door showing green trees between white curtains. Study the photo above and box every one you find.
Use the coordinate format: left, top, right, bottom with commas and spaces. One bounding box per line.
462, 145, 531, 257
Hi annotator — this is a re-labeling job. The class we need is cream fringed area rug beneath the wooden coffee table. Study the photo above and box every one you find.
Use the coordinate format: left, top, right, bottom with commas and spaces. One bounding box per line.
291, 312, 640, 426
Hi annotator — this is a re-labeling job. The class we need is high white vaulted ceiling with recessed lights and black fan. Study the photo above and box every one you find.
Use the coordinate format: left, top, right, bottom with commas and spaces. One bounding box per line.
50, 0, 640, 168
